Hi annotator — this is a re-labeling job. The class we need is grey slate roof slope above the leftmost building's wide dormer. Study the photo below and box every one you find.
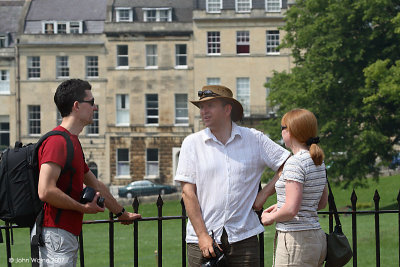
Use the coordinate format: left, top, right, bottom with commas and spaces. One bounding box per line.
26, 0, 107, 21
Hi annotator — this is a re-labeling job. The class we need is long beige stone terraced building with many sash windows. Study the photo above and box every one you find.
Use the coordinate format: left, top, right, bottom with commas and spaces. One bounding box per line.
0, 0, 292, 186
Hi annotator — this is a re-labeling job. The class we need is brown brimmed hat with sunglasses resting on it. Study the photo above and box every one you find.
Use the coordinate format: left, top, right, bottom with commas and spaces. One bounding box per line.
190, 85, 243, 121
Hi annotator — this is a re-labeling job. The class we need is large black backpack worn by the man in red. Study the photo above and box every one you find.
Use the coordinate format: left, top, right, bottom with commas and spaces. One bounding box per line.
0, 131, 74, 227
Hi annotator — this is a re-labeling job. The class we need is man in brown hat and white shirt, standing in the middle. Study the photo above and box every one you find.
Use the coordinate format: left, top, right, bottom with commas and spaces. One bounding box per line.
175, 85, 290, 267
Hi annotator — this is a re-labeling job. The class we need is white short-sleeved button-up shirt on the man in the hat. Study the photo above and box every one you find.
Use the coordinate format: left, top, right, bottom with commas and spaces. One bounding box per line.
175, 123, 290, 243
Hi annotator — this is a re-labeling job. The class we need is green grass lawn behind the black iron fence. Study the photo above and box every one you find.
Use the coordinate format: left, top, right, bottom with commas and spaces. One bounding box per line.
0, 175, 400, 267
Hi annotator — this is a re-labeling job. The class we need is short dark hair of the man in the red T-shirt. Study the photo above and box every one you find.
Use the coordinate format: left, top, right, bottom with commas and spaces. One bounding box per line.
54, 79, 92, 118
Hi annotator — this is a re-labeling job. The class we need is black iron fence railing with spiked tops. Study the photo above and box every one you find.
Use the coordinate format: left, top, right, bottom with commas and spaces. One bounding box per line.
0, 190, 400, 267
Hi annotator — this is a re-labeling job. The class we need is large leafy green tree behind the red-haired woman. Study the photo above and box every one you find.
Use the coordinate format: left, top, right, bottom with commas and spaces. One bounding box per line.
265, 0, 400, 186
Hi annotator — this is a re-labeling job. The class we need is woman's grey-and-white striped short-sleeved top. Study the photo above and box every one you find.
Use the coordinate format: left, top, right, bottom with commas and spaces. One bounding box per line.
275, 150, 326, 232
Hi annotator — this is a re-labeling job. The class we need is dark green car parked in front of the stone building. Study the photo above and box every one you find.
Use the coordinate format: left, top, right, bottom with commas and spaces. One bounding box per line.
118, 180, 177, 198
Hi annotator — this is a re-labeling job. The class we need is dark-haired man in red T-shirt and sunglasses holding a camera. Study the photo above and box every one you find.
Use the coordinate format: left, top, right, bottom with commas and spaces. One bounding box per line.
32, 79, 141, 266
